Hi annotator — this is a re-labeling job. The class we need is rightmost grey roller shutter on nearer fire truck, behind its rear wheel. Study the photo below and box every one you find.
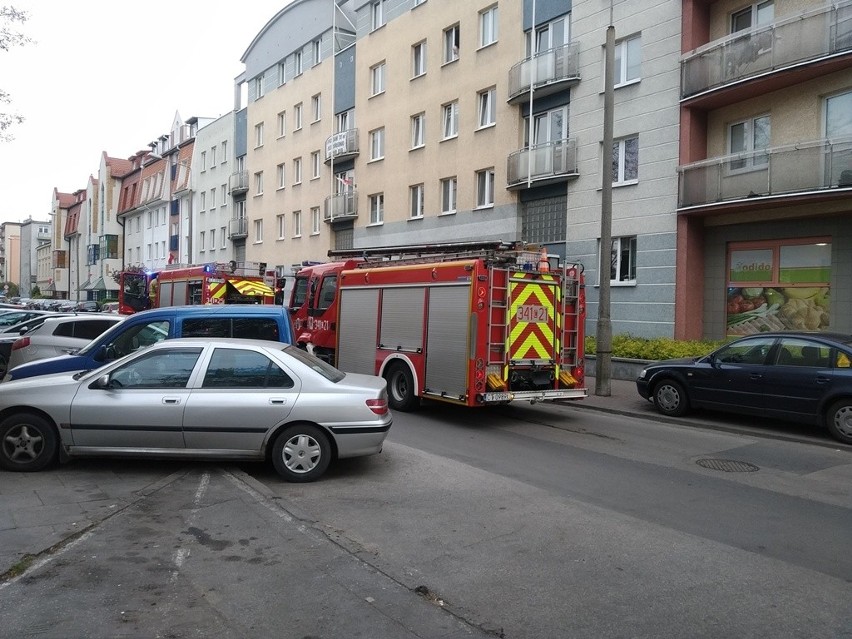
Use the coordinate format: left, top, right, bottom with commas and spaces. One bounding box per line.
426, 283, 474, 397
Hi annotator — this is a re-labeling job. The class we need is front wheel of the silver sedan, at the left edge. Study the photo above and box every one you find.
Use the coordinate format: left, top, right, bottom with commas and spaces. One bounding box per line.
0, 413, 59, 472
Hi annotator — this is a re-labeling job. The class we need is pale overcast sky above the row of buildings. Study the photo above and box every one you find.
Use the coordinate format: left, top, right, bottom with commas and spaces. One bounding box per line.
0, 0, 290, 222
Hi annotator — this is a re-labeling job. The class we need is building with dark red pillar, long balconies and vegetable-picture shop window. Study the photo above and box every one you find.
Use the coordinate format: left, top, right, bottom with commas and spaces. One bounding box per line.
675, 0, 852, 338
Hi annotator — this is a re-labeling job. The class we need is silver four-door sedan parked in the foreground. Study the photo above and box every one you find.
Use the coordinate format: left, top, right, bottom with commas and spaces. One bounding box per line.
0, 338, 392, 482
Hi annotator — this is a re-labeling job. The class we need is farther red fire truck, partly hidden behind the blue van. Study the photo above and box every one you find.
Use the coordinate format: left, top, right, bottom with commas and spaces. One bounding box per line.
118, 262, 275, 314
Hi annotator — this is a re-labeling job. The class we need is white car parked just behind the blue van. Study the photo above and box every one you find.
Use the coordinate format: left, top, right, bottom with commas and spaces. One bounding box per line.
8, 315, 124, 370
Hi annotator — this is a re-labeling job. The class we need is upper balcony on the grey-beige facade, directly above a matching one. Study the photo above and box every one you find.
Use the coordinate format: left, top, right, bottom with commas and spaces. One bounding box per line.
509, 42, 580, 104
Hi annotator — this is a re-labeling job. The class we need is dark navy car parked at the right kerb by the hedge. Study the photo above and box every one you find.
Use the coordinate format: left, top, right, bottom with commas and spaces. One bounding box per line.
636, 331, 852, 444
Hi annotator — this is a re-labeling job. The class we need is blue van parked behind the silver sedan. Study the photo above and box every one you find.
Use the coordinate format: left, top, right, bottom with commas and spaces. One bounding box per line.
3, 304, 293, 382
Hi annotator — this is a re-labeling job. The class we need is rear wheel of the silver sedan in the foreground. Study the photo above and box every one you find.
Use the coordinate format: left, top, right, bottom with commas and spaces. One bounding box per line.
272, 424, 331, 482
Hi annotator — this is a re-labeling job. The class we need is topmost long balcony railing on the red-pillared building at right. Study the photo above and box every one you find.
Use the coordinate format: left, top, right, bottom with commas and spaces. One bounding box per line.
681, 2, 852, 98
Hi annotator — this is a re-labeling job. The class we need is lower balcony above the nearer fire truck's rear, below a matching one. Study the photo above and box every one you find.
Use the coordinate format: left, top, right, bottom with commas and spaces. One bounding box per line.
506, 138, 579, 191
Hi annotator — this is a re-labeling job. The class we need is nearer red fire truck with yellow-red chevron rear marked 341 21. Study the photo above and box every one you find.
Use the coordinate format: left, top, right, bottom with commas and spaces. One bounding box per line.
302, 242, 587, 411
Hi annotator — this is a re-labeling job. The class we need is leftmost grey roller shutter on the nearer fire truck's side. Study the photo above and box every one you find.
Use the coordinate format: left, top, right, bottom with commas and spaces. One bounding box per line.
336, 288, 379, 375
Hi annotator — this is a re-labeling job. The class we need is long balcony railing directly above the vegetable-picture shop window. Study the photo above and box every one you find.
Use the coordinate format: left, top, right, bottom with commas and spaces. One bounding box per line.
678, 137, 852, 208
